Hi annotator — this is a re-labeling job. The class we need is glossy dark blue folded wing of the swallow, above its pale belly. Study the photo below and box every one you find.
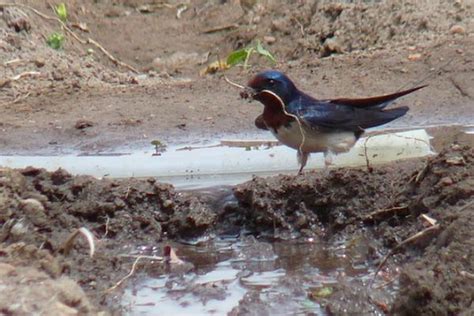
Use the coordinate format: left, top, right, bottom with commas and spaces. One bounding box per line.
287, 99, 408, 131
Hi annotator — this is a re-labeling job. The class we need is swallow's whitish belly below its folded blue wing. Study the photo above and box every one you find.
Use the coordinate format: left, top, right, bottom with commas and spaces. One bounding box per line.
272, 122, 357, 153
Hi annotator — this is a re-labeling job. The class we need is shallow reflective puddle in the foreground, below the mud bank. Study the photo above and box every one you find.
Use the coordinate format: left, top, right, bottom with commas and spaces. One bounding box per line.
123, 236, 397, 315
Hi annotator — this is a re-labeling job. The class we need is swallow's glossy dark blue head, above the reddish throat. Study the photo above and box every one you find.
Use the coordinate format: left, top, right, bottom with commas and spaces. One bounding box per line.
248, 70, 298, 105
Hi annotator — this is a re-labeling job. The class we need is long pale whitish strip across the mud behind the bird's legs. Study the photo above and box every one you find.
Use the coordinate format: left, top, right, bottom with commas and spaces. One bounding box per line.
0, 127, 462, 189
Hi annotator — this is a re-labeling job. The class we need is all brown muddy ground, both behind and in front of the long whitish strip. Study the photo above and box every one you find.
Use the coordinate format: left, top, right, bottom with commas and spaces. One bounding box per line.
0, 0, 474, 315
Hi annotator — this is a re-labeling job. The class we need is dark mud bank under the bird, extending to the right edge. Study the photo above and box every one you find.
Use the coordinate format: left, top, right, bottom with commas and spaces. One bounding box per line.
234, 145, 474, 315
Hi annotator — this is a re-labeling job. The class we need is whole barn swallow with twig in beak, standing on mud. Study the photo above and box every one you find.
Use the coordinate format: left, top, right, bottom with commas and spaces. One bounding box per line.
241, 70, 425, 174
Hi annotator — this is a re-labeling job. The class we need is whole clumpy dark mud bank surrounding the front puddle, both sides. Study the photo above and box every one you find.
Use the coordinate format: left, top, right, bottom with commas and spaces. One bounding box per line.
0, 145, 474, 314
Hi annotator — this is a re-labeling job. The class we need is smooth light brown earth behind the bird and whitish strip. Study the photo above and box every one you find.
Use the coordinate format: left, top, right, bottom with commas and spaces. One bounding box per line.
0, 1, 474, 153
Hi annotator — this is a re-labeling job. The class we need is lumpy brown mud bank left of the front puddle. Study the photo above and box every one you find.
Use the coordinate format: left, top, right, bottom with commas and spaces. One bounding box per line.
0, 168, 216, 314
